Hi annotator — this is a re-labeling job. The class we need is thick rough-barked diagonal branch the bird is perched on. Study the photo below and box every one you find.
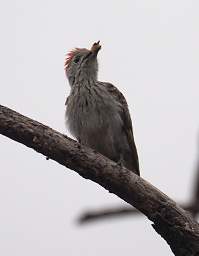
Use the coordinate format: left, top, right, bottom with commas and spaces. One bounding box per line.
0, 105, 199, 256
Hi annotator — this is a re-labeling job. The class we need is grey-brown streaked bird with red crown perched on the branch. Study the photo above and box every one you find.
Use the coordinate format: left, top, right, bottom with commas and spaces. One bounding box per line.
64, 41, 140, 176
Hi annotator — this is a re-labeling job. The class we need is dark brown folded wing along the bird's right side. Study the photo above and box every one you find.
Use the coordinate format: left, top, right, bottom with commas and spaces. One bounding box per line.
102, 83, 140, 175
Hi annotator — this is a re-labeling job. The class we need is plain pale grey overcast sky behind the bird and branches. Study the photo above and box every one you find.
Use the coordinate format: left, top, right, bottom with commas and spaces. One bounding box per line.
0, 0, 199, 256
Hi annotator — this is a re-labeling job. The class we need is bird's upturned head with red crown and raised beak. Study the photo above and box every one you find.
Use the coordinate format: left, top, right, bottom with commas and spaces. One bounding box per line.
64, 41, 101, 86
